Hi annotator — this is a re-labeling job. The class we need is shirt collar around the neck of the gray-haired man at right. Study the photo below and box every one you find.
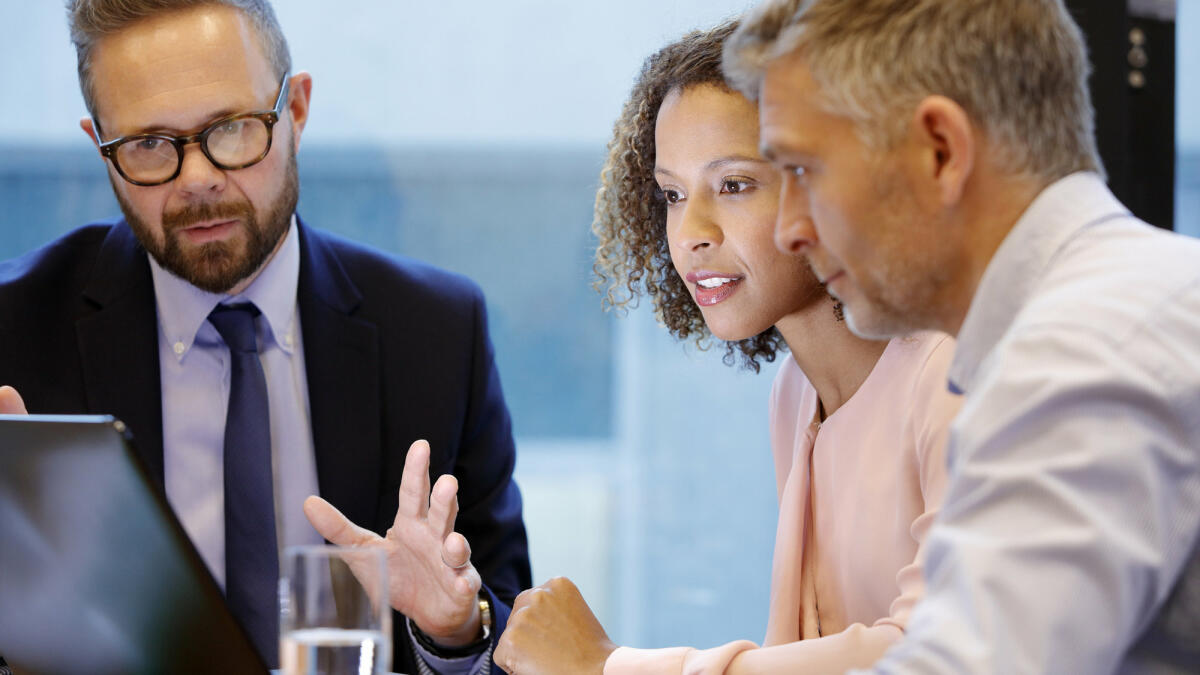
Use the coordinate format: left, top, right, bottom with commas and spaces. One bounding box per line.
949, 172, 1129, 394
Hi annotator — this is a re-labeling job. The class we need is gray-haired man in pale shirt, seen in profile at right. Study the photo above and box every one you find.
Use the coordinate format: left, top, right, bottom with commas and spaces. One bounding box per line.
725, 0, 1200, 674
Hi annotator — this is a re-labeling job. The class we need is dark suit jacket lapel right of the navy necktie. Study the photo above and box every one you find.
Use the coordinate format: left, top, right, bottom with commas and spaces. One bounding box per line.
298, 219, 383, 526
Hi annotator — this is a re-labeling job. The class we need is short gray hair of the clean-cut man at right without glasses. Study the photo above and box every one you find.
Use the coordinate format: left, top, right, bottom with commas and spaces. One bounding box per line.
722, 0, 1104, 181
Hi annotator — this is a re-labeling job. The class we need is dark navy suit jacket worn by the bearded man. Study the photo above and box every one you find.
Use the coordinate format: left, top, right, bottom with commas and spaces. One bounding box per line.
0, 219, 532, 673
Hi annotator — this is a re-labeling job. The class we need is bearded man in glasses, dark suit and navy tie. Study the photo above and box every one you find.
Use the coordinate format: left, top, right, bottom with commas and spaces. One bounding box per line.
0, 0, 530, 673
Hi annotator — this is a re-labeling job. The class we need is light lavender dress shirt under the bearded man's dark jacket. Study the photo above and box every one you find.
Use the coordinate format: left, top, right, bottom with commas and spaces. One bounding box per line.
150, 216, 324, 587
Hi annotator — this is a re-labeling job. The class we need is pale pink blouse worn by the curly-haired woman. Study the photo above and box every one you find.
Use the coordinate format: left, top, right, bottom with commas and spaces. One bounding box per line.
604, 333, 960, 675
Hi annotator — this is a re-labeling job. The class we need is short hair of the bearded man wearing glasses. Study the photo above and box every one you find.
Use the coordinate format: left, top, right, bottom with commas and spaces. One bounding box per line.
67, 0, 292, 124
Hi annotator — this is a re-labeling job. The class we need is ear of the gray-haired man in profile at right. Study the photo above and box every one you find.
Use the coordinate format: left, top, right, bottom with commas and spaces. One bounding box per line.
910, 96, 978, 207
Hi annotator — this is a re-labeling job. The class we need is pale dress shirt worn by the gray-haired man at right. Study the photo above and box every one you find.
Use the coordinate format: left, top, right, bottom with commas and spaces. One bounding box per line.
872, 173, 1200, 675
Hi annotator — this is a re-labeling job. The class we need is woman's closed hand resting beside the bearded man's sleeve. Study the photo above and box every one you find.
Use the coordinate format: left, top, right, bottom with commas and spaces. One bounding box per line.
494, 577, 617, 675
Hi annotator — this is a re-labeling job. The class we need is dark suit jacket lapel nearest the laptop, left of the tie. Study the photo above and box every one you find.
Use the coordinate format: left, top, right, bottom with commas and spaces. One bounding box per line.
76, 220, 163, 485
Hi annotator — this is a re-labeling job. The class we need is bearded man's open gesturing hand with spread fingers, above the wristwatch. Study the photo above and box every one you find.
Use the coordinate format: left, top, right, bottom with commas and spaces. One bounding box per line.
304, 441, 481, 646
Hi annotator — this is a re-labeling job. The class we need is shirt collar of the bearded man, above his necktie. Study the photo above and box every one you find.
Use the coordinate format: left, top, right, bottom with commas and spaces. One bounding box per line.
150, 215, 300, 360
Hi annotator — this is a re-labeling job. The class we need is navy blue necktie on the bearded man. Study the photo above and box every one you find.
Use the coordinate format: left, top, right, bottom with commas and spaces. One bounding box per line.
209, 303, 280, 668
